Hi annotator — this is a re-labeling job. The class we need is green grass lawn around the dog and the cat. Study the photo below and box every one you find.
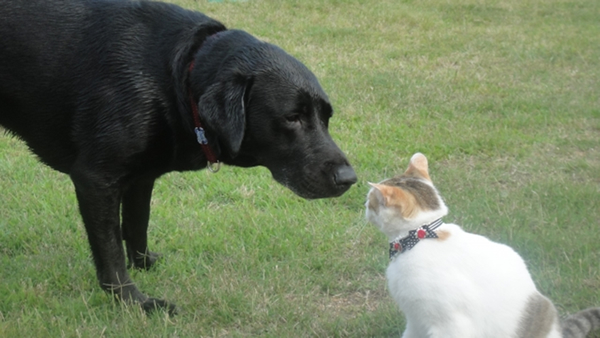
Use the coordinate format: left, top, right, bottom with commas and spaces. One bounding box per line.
0, 0, 600, 337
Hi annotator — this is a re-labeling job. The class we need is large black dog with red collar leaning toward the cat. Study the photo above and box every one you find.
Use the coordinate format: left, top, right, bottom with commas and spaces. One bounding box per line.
0, 0, 356, 311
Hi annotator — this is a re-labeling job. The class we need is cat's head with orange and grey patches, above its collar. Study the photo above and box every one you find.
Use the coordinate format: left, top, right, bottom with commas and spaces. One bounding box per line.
365, 153, 448, 240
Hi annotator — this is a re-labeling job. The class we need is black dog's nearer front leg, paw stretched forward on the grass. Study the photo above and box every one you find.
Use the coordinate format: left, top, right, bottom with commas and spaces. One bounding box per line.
71, 166, 175, 313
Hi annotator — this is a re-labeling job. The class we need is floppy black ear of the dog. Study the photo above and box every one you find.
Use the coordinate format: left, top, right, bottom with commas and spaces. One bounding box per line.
198, 76, 252, 157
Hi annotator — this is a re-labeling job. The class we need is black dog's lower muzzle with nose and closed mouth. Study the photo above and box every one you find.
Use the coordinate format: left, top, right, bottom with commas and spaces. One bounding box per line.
271, 164, 357, 199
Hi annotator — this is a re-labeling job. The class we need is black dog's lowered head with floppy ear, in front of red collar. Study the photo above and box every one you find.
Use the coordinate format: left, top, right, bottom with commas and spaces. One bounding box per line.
191, 30, 356, 198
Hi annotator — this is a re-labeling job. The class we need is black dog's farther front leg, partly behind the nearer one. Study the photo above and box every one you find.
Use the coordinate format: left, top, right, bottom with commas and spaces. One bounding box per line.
121, 179, 159, 270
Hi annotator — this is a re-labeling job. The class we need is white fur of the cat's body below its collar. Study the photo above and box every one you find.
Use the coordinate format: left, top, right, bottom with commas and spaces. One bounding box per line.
386, 224, 537, 337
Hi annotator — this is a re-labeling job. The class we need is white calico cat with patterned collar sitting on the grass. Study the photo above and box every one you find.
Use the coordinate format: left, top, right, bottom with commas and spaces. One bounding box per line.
366, 153, 600, 338
